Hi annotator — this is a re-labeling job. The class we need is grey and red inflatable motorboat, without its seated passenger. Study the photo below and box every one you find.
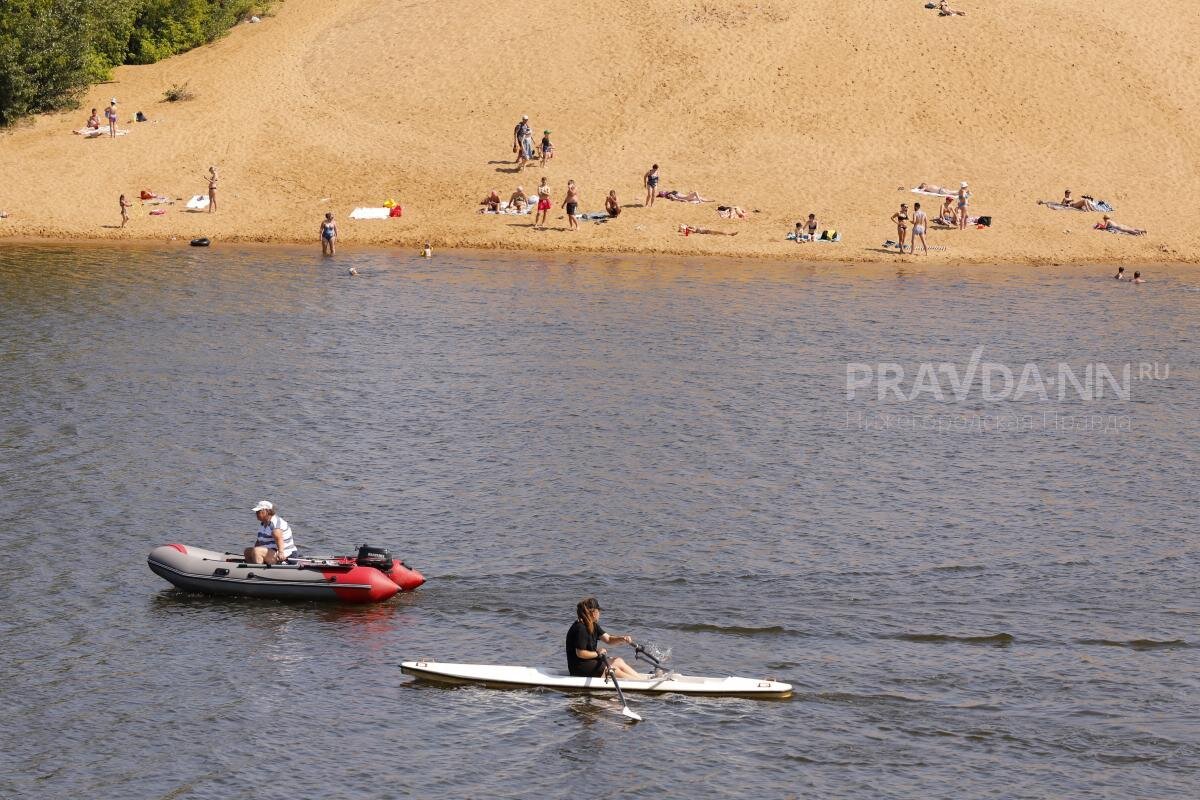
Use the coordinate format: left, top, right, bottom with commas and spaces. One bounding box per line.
146, 545, 425, 603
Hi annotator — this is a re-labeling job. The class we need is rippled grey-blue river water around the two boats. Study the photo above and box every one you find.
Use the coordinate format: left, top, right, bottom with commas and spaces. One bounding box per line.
0, 245, 1200, 800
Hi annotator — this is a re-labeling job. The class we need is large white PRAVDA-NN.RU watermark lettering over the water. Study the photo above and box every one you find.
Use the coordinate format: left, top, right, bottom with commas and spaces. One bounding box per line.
846, 344, 1171, 402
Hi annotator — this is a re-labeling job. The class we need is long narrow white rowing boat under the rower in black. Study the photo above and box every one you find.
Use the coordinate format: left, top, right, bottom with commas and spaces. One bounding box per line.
400, 661, 792, 697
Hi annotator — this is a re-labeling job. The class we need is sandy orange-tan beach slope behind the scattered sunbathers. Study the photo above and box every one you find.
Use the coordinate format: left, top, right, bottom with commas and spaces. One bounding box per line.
0, 0, 1200, 265
